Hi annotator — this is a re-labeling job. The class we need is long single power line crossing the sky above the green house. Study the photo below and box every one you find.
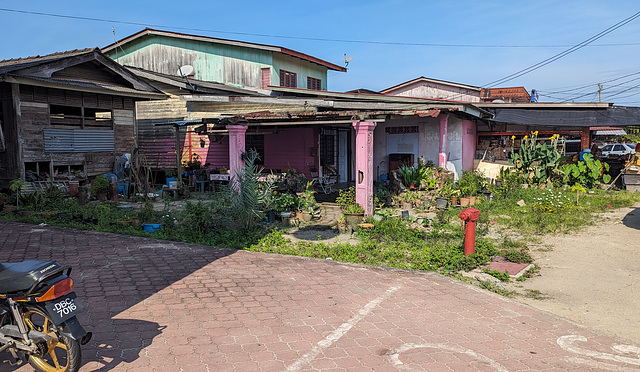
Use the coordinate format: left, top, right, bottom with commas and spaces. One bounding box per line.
0, 8, 640, 48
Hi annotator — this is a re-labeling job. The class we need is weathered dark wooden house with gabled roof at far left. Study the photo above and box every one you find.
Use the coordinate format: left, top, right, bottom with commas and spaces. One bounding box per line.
0, 48, 165, 187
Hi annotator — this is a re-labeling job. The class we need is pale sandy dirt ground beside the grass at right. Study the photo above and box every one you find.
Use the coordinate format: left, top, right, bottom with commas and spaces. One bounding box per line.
506, 203, 640, 344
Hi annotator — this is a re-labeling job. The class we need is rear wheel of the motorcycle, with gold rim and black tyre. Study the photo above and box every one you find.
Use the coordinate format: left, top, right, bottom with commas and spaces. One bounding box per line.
22, 306, 81, 372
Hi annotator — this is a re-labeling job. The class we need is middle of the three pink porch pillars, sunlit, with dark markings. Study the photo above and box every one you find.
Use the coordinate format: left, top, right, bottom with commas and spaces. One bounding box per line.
353, 121, 377, 216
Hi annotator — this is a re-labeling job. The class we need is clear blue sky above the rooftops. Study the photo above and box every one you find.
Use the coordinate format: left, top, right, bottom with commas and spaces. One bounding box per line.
0, 0, 640, 106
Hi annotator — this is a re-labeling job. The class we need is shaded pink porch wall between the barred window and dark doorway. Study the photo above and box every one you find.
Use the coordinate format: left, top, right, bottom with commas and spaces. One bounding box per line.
264, 127, 318, 178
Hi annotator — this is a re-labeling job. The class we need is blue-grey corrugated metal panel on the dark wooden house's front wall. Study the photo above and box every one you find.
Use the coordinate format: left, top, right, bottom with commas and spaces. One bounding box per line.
44, 129, 115, 152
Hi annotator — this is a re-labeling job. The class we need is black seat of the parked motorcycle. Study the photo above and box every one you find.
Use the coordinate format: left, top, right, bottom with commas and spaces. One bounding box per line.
0, 260, 62, 294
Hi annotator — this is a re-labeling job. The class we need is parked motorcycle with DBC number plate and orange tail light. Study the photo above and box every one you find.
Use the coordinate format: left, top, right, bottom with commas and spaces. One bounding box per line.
0, 260, 92, 372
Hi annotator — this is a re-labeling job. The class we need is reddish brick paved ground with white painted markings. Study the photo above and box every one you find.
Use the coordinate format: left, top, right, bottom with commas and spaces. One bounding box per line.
0, 221, 640, 372
